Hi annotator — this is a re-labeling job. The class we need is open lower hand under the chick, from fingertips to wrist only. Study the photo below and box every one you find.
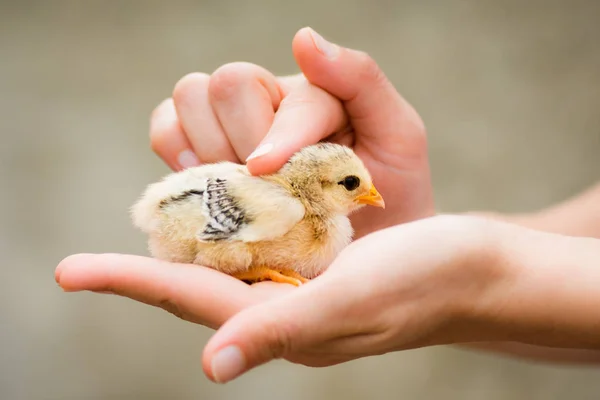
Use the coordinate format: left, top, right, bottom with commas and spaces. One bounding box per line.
56, 216, 507, 382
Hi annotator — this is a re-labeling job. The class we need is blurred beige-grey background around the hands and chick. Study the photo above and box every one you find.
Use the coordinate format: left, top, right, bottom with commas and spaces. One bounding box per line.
0, 0, 600, 400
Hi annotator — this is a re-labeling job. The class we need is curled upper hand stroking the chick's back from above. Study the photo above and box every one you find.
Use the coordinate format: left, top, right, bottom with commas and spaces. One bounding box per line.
150, 28, 434, 238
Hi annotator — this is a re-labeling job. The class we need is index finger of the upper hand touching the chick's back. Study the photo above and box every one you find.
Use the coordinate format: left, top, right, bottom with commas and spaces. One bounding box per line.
246, 82, 348, 175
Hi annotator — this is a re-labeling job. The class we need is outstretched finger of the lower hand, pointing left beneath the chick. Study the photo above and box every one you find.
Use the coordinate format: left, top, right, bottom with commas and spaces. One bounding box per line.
55, 254, 246, 328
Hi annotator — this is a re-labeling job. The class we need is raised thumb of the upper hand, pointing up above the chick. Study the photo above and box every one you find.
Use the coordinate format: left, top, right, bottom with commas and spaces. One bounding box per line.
292, 28, 425, 156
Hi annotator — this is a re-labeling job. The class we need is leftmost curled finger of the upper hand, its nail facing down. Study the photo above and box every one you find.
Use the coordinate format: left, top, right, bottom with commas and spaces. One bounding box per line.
150, 98, 200, 171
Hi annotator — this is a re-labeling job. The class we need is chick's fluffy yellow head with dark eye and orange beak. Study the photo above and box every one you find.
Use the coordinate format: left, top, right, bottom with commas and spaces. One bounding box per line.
279, 143, 385, 215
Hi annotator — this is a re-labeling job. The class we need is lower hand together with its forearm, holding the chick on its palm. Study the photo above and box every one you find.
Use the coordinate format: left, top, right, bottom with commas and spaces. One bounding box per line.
56, 216, 600, 382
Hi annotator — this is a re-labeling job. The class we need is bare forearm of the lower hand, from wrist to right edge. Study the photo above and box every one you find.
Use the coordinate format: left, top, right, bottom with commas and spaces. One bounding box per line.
465, 226, 600, 361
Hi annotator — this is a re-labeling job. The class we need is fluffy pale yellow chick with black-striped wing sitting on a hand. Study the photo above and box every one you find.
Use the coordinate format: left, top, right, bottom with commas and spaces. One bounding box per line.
131, 143, 385, 286
